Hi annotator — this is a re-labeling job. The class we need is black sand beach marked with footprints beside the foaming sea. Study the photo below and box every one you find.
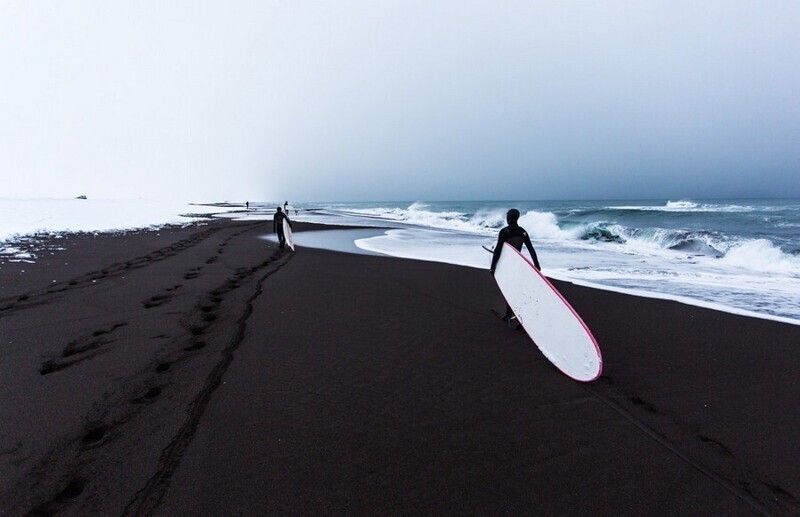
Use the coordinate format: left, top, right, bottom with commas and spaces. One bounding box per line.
0, 217, 800, 515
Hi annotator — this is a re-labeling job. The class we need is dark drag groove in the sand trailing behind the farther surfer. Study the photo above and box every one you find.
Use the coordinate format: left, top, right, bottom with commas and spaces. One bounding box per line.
122, 248, 294, 515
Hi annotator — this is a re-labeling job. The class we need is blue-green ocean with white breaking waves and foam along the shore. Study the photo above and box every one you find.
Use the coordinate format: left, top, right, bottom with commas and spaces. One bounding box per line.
269, 199, 800, 324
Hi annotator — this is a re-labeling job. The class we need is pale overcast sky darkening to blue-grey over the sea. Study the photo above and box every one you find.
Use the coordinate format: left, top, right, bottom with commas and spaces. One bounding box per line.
0, 0, 800, 201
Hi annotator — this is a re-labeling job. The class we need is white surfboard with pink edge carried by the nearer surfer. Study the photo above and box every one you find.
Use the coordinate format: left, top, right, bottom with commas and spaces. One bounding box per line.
494, 243, 603, 382
